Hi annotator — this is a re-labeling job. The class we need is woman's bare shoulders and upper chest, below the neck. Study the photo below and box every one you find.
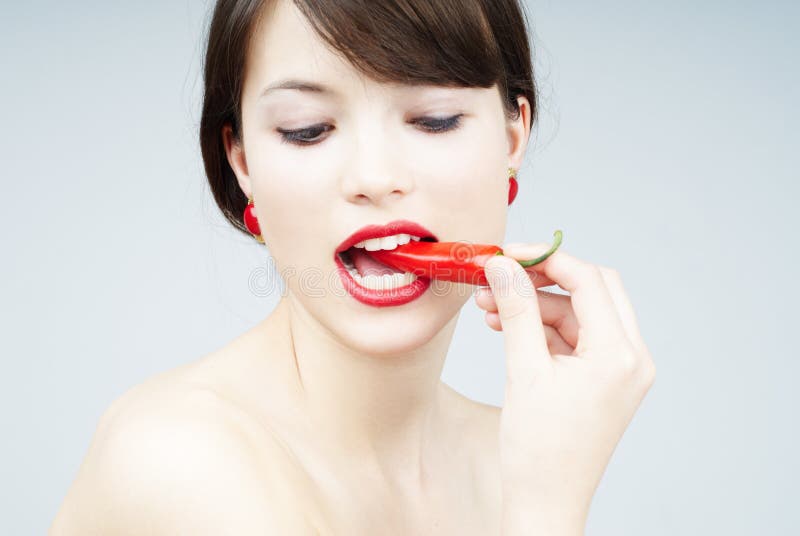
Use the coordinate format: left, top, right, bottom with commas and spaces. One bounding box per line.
50, 300, 501, 535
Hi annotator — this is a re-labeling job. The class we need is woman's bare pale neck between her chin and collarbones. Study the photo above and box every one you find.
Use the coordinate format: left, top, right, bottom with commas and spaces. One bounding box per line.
268, 294, 458, 483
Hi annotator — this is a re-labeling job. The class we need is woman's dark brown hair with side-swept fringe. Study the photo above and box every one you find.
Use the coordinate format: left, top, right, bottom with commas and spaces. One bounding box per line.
200, 0, 538, 236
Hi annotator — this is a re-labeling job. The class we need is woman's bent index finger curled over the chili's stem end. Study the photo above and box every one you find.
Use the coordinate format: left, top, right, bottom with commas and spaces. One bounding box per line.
503, 244, 626, 355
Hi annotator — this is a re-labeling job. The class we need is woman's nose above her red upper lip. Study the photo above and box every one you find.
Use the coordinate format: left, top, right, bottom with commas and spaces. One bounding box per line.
342, 121, 413, 206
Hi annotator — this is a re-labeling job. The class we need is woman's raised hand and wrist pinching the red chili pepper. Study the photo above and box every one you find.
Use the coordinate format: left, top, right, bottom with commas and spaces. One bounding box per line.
476, 244, 655, 534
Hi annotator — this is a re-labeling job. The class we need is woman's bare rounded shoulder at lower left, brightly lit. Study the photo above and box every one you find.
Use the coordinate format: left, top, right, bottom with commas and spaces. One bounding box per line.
49, 369, 316, 536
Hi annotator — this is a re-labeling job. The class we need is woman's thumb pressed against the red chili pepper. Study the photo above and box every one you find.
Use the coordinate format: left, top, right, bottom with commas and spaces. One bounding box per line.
484, 255, 551, 382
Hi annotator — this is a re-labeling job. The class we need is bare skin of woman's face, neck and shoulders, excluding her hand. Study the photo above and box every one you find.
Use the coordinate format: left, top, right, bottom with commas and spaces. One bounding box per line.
52, 2, 531, 535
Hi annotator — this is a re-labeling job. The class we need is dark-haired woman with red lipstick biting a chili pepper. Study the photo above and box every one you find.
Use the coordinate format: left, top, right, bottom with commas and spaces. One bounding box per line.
51, 0, 654, 536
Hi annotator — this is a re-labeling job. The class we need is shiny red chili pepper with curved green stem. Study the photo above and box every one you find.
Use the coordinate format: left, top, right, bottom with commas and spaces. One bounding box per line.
365, 231, 562, 286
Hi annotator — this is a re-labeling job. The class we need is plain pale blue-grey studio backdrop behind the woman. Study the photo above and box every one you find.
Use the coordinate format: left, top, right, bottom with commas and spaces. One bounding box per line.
0, 0, 800, 536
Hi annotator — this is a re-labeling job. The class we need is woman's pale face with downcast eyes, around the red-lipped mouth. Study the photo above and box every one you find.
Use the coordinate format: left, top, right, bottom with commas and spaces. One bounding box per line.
226, 1, 529, 355
